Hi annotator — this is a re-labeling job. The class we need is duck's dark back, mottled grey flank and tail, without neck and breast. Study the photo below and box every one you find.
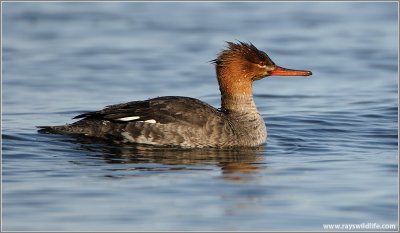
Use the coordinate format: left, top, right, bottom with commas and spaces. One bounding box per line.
40, 96, 235, 147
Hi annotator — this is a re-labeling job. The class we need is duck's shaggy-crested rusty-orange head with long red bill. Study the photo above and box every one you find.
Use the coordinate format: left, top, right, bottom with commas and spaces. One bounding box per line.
212, 41, 312, 95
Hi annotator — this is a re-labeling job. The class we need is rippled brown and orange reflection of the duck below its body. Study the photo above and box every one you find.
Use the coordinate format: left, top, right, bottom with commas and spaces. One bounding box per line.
67, 137, 266, 180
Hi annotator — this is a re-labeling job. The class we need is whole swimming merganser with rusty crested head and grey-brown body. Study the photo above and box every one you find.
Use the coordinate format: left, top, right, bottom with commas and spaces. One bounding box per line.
39, 41, 312, 147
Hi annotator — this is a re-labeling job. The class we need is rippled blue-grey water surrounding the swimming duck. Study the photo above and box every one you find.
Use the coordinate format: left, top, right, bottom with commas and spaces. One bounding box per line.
2, 2, 398, 231
